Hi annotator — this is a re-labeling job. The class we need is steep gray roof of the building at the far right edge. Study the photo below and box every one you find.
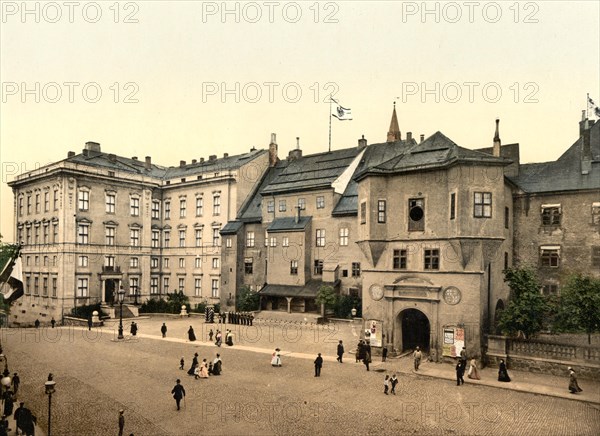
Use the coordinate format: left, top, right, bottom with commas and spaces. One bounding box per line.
511, 121, 600, 193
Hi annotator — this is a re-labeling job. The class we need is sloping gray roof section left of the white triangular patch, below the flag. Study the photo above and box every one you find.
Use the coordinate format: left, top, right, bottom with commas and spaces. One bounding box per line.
262, 147, 360, 195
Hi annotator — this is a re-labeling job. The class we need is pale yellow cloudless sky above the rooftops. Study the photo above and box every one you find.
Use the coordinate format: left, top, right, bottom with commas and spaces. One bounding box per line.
0, 1, 600, 241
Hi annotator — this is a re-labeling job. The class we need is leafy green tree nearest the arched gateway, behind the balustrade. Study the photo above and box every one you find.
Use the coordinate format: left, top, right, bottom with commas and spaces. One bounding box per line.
498, 267, 550, 339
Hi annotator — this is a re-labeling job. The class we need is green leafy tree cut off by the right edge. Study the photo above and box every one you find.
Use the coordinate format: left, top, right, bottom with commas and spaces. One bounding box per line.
555, 274, 600, 344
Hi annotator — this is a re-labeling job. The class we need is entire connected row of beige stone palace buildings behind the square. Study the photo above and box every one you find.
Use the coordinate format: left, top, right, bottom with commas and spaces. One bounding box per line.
9, 108, 600, 360
